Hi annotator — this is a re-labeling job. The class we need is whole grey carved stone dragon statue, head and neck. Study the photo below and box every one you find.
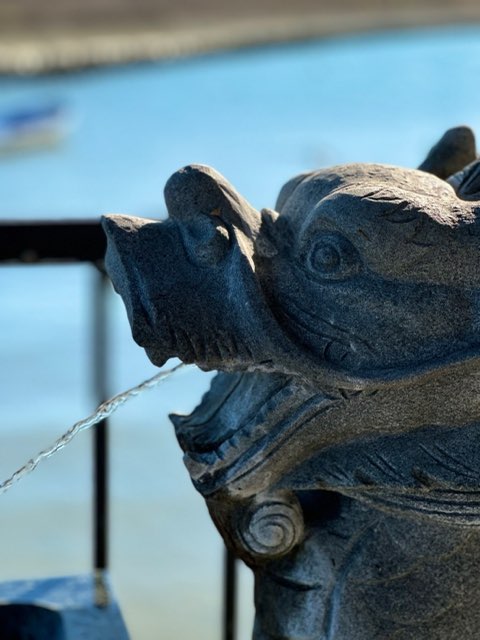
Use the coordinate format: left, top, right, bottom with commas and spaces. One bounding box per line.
104, 127, 480, 640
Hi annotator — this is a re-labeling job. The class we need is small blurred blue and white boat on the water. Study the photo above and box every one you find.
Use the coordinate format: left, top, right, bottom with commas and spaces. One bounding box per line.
0, 103, 68, 155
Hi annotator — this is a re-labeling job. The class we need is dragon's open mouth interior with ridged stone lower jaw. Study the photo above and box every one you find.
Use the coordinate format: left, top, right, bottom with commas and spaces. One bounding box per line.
170, 372, 338, 494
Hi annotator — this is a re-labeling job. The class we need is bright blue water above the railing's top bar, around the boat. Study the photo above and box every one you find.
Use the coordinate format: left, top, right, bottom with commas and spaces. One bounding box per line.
0, 27, 480, 217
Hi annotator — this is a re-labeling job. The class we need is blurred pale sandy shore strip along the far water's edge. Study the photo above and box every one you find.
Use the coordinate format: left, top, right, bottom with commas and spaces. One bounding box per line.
0, 4, 480, 75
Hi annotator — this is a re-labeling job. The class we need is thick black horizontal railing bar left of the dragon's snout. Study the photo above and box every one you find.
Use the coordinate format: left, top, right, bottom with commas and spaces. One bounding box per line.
0, 219, 106, 264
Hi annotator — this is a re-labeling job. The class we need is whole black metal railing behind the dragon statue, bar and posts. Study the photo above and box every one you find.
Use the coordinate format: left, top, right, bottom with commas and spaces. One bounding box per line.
0, 220, 237, 640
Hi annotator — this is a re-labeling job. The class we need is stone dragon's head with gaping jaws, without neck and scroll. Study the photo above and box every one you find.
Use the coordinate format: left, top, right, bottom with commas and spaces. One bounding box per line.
104, 130, 480, 544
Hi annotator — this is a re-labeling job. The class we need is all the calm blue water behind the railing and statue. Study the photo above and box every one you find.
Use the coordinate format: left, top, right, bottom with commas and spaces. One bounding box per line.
0, 27, 480, 640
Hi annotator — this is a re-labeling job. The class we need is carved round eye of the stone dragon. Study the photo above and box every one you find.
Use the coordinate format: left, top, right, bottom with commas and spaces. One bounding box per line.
306, 233, 360, 280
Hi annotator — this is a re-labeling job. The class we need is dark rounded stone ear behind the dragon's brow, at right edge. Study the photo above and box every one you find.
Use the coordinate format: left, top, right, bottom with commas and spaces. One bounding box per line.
418, 126, 477, 180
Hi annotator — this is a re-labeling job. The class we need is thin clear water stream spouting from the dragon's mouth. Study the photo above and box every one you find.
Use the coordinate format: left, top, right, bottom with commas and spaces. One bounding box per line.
0, 363, 185, 494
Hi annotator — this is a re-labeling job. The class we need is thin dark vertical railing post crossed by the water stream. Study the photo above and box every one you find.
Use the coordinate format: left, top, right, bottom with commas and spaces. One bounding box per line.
92, 270, 109, 570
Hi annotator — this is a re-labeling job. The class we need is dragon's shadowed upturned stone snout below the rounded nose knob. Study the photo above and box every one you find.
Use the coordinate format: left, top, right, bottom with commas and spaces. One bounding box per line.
103, 213, 284, 370
